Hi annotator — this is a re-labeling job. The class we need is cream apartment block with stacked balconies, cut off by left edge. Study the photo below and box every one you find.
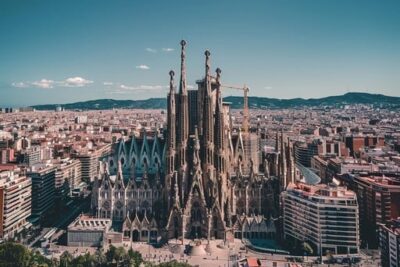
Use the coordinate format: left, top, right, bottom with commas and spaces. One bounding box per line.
0, 169, 32, 239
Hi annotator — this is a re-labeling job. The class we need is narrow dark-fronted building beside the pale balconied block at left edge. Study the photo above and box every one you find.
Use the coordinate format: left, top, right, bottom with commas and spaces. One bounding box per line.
27, 164, 56, 223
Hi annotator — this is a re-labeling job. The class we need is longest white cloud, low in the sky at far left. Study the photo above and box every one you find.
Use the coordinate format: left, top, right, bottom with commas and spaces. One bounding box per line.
12, 77, 93, 89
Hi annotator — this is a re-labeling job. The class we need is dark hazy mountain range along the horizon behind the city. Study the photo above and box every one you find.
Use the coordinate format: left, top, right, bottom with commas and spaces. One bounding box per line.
32, 93, 400, 110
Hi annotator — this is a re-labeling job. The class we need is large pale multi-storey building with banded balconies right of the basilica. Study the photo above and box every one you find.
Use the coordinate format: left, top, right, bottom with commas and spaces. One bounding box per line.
281, 183, 360, 255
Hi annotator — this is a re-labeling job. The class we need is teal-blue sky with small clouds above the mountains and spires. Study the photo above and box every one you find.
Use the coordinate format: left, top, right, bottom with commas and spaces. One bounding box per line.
0, 0, 400, 106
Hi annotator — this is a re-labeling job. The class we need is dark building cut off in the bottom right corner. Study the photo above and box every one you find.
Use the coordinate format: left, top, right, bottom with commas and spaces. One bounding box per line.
379, 218, 400, 267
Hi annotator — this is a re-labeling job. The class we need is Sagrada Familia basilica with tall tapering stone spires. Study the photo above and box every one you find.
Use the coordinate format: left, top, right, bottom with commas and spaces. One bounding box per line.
91, 41, 294, 242
